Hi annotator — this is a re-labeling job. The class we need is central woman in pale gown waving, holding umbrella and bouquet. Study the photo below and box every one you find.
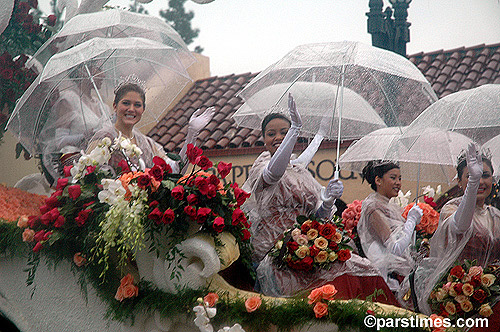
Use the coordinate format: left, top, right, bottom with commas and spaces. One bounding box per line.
243, 96, 397, 304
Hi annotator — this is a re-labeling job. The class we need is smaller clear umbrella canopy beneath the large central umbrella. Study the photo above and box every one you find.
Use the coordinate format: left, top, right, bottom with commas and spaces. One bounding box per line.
233, 81, 386, 139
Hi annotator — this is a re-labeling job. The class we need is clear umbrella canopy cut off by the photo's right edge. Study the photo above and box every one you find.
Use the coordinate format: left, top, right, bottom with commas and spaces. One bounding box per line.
403, 84, 500, 146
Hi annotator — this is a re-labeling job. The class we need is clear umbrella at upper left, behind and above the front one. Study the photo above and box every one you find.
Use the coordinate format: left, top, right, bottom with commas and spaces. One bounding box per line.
28, 9, 196, 68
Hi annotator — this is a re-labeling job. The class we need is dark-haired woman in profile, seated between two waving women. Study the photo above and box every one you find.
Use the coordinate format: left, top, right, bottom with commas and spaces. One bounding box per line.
357, 160, 422, 291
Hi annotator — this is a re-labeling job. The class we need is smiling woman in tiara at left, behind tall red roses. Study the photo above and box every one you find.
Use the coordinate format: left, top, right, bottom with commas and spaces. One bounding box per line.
87, 80, 215, 172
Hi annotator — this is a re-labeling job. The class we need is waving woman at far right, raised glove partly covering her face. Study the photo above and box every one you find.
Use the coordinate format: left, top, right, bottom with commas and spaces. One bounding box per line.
415, 144, 500, 322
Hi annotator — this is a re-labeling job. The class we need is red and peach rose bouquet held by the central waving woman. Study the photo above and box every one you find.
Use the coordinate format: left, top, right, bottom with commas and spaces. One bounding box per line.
269, 215, 351, 271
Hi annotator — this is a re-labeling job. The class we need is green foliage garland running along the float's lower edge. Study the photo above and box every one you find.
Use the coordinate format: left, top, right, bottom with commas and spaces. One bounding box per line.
0, 221, 458, 332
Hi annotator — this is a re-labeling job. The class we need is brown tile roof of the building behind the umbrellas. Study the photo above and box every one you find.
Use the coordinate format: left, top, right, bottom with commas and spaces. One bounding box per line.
148, 43, 500, 155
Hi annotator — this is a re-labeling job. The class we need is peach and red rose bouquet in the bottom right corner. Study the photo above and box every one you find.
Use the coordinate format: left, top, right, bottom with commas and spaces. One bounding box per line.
428, 260, 500, 320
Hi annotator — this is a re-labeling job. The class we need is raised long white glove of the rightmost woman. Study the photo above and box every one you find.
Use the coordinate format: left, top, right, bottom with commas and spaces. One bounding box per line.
452, 143, 483, 234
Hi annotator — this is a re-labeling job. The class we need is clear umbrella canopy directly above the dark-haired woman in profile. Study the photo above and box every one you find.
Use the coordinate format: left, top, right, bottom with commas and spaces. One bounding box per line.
339, 127, 472, 184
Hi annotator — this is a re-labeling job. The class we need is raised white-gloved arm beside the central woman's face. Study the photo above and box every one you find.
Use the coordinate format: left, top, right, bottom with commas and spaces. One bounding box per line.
262, 94, 302, 185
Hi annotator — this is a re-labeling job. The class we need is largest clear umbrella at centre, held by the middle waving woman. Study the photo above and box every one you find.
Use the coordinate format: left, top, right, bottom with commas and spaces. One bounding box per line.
235, 41, 437, 174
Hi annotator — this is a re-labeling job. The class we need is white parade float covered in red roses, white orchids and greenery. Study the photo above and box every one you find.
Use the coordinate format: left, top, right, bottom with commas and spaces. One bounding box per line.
0, 138, 442, 332
